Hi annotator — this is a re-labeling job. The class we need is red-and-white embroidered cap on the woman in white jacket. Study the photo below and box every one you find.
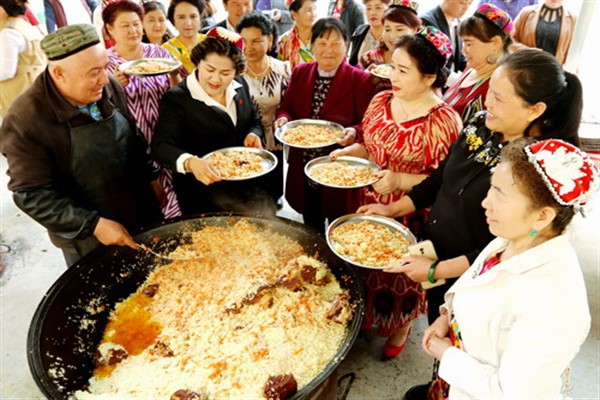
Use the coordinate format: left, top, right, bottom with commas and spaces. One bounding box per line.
524, 139, 600, 209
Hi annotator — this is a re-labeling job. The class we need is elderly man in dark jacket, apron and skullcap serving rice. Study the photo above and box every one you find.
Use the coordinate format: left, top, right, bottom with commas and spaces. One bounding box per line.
0, 24, 162, 265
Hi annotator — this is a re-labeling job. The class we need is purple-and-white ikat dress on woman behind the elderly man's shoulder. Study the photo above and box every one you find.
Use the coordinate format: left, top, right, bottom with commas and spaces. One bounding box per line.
108, 43, 181, 218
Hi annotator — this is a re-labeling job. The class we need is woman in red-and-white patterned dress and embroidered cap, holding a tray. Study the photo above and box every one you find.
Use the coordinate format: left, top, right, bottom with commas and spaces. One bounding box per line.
331, 27, 462, 359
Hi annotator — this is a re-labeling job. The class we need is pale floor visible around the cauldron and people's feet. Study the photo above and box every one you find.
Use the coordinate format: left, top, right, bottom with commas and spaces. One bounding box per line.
0, 156, 600, 400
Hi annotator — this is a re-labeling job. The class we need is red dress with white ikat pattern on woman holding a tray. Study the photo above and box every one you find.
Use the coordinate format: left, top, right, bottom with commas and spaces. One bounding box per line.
358, 91, 462, 336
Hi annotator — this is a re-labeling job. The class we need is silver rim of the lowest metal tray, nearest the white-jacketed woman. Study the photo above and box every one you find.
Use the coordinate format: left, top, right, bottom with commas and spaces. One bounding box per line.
325, 214, 417, 270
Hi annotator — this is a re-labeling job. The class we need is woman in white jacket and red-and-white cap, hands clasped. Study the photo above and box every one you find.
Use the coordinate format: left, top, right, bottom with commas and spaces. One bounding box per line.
422, 139, 599, 399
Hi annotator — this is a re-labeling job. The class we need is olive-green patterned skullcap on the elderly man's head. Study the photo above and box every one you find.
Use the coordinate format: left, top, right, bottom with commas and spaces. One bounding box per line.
40, 24, 100, 61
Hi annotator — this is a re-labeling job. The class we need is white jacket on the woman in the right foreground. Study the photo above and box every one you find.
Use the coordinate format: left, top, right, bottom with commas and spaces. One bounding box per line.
439, 235, 591, 399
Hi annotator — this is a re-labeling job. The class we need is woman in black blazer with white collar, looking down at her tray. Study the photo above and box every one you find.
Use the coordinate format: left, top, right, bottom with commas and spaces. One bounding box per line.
152, 28, 275, 215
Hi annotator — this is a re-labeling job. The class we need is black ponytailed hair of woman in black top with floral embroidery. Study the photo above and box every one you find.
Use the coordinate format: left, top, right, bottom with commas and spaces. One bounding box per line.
499, 49, 583, 146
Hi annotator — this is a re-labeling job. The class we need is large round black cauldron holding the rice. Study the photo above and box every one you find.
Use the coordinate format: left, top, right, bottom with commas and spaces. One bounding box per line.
27, 214, 364, 399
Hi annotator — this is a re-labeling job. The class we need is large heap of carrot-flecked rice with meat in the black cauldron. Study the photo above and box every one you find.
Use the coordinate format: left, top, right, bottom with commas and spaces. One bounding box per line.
75, 221, 353, 399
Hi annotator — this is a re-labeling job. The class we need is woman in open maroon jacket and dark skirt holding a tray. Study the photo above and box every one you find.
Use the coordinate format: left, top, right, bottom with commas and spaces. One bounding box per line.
274, 18, 375, 232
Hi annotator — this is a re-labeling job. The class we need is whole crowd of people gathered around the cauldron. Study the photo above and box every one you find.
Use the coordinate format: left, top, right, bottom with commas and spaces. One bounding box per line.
0, 0, 600, 399
